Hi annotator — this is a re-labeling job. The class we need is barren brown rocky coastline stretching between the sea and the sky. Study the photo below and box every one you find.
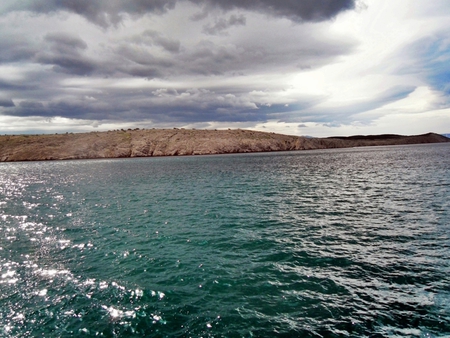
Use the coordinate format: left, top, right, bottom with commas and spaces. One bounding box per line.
0, 128, 450, 162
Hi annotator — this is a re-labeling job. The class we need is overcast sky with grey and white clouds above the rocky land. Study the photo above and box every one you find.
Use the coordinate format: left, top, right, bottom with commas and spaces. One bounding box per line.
0, 0, 450, 137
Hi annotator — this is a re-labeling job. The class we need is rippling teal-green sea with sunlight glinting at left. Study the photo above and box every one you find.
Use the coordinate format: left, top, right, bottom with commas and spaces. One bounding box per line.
0, 144, 450, 337
